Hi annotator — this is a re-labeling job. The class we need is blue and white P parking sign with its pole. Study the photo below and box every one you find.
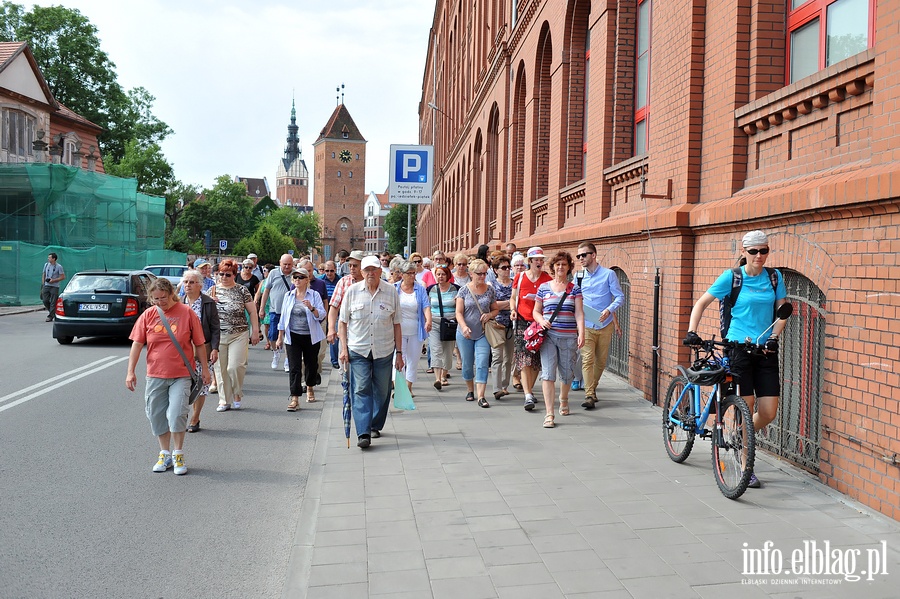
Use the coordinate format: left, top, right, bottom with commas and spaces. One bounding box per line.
388, 144, 434, 251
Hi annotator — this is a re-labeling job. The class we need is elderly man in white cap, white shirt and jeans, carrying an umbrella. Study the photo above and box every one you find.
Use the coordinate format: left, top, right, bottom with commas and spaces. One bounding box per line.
338, 256, 404, 449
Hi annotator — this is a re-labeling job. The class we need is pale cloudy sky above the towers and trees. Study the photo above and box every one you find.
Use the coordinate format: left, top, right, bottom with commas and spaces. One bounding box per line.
26, 0, 434, 202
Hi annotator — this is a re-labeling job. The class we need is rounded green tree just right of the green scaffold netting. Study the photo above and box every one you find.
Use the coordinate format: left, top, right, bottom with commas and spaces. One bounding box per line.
178, 175, 253, 244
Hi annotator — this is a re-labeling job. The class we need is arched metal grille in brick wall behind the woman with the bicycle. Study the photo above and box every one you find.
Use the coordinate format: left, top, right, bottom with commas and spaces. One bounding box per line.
756, 269, 826, 472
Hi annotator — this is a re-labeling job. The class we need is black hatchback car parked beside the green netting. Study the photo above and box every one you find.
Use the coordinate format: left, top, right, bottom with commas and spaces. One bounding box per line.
53, 270, 156, 345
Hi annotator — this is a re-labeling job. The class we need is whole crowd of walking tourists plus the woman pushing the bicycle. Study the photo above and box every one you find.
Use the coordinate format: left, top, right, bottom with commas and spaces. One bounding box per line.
121, 231, 785, 486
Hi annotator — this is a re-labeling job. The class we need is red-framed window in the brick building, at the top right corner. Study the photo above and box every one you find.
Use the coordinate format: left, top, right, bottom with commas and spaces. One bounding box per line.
787, 0, 875, 83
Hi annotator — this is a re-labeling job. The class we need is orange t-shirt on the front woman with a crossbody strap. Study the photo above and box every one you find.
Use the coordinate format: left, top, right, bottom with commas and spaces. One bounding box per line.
129, 304, 205, 379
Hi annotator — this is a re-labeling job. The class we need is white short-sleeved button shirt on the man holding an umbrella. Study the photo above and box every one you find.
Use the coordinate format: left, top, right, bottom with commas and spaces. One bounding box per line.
340, 279, 400, 359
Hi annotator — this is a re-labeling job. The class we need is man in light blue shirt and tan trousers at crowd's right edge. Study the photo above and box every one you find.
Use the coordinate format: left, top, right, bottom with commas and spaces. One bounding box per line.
575, 242, 625, 410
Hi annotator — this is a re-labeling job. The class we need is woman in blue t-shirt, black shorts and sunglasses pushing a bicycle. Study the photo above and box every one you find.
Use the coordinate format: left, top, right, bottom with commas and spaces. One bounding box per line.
684, 231, 787, 489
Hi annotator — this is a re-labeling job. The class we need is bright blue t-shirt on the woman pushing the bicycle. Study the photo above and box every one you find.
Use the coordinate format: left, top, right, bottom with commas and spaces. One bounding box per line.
707, 266, 787, 343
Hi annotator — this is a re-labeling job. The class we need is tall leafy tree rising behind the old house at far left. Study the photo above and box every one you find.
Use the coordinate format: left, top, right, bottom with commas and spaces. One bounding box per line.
0, 0, 172, 164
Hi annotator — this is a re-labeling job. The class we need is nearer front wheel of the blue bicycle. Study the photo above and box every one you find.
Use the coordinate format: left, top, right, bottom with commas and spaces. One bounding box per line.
712, 395, 756, 499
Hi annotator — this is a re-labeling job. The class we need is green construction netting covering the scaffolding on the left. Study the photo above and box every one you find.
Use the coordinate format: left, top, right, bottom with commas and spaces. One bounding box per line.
0, 163, 186, 305
